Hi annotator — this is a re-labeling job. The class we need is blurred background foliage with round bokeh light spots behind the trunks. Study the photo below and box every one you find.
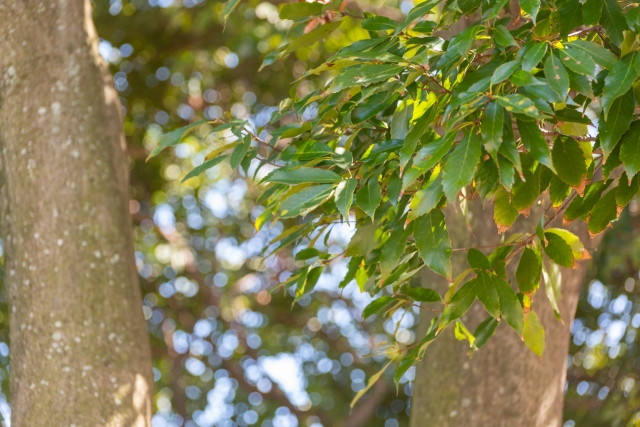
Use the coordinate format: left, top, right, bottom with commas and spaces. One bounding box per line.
0, 0, 640, 427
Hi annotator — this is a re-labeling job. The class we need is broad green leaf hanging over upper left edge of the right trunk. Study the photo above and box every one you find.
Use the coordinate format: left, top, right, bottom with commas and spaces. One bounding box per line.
413, 209, 451, 281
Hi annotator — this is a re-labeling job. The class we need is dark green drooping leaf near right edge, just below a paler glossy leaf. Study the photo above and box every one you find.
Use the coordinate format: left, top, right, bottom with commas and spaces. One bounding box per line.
598, 90, 635, 160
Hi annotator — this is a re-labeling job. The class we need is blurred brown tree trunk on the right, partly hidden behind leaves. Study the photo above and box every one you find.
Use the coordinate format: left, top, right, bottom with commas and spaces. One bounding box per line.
411, 198, 599, 427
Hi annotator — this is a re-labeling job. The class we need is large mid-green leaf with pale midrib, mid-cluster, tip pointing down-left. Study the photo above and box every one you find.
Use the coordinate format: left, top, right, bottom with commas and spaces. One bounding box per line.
442, 130, 481, 201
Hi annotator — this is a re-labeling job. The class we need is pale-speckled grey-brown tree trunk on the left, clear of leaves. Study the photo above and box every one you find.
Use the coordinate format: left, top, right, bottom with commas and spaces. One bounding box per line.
0, 0, 153, 427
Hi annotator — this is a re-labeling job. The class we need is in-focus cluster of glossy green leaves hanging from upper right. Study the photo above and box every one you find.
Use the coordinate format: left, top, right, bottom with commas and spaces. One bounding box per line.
152, 0, 640, 399
